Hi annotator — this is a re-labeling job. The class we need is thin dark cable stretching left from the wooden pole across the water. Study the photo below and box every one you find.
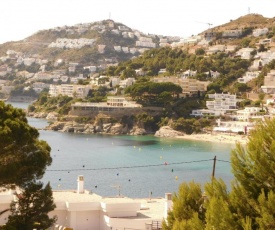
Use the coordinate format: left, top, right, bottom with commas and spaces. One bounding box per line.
46, 159, 216, 172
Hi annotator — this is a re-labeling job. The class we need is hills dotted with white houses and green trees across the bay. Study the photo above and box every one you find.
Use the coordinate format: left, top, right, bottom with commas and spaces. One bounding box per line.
0, 14, 275, 136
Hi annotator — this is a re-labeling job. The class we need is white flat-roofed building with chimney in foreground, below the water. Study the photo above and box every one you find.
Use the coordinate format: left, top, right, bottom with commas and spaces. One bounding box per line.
0, 176, 172, 230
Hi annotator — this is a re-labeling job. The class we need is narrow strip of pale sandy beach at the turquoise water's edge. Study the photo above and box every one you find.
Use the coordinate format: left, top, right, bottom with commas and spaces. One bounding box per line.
177, 133, 248, 144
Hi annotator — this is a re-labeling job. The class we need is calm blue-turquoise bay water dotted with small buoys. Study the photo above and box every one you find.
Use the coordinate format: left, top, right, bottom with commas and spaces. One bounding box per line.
7, 102, 235, 198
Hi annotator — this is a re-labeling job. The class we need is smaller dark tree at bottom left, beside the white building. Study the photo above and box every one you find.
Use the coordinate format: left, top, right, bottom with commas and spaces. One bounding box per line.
4, 182, 57, 230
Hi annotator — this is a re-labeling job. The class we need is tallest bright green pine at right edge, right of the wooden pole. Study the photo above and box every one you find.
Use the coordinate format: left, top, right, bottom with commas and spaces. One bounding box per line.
231, 119, 275, 229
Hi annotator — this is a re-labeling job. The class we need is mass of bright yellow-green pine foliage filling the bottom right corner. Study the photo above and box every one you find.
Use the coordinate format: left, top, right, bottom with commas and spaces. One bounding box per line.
163, 118, 275, 230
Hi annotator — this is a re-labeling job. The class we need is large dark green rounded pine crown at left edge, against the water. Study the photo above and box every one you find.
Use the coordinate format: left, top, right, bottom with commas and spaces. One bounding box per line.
0, 101, 52, 186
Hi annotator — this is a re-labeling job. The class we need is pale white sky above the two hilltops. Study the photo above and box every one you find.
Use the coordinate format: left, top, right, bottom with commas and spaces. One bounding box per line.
0, 0, 275, 44
